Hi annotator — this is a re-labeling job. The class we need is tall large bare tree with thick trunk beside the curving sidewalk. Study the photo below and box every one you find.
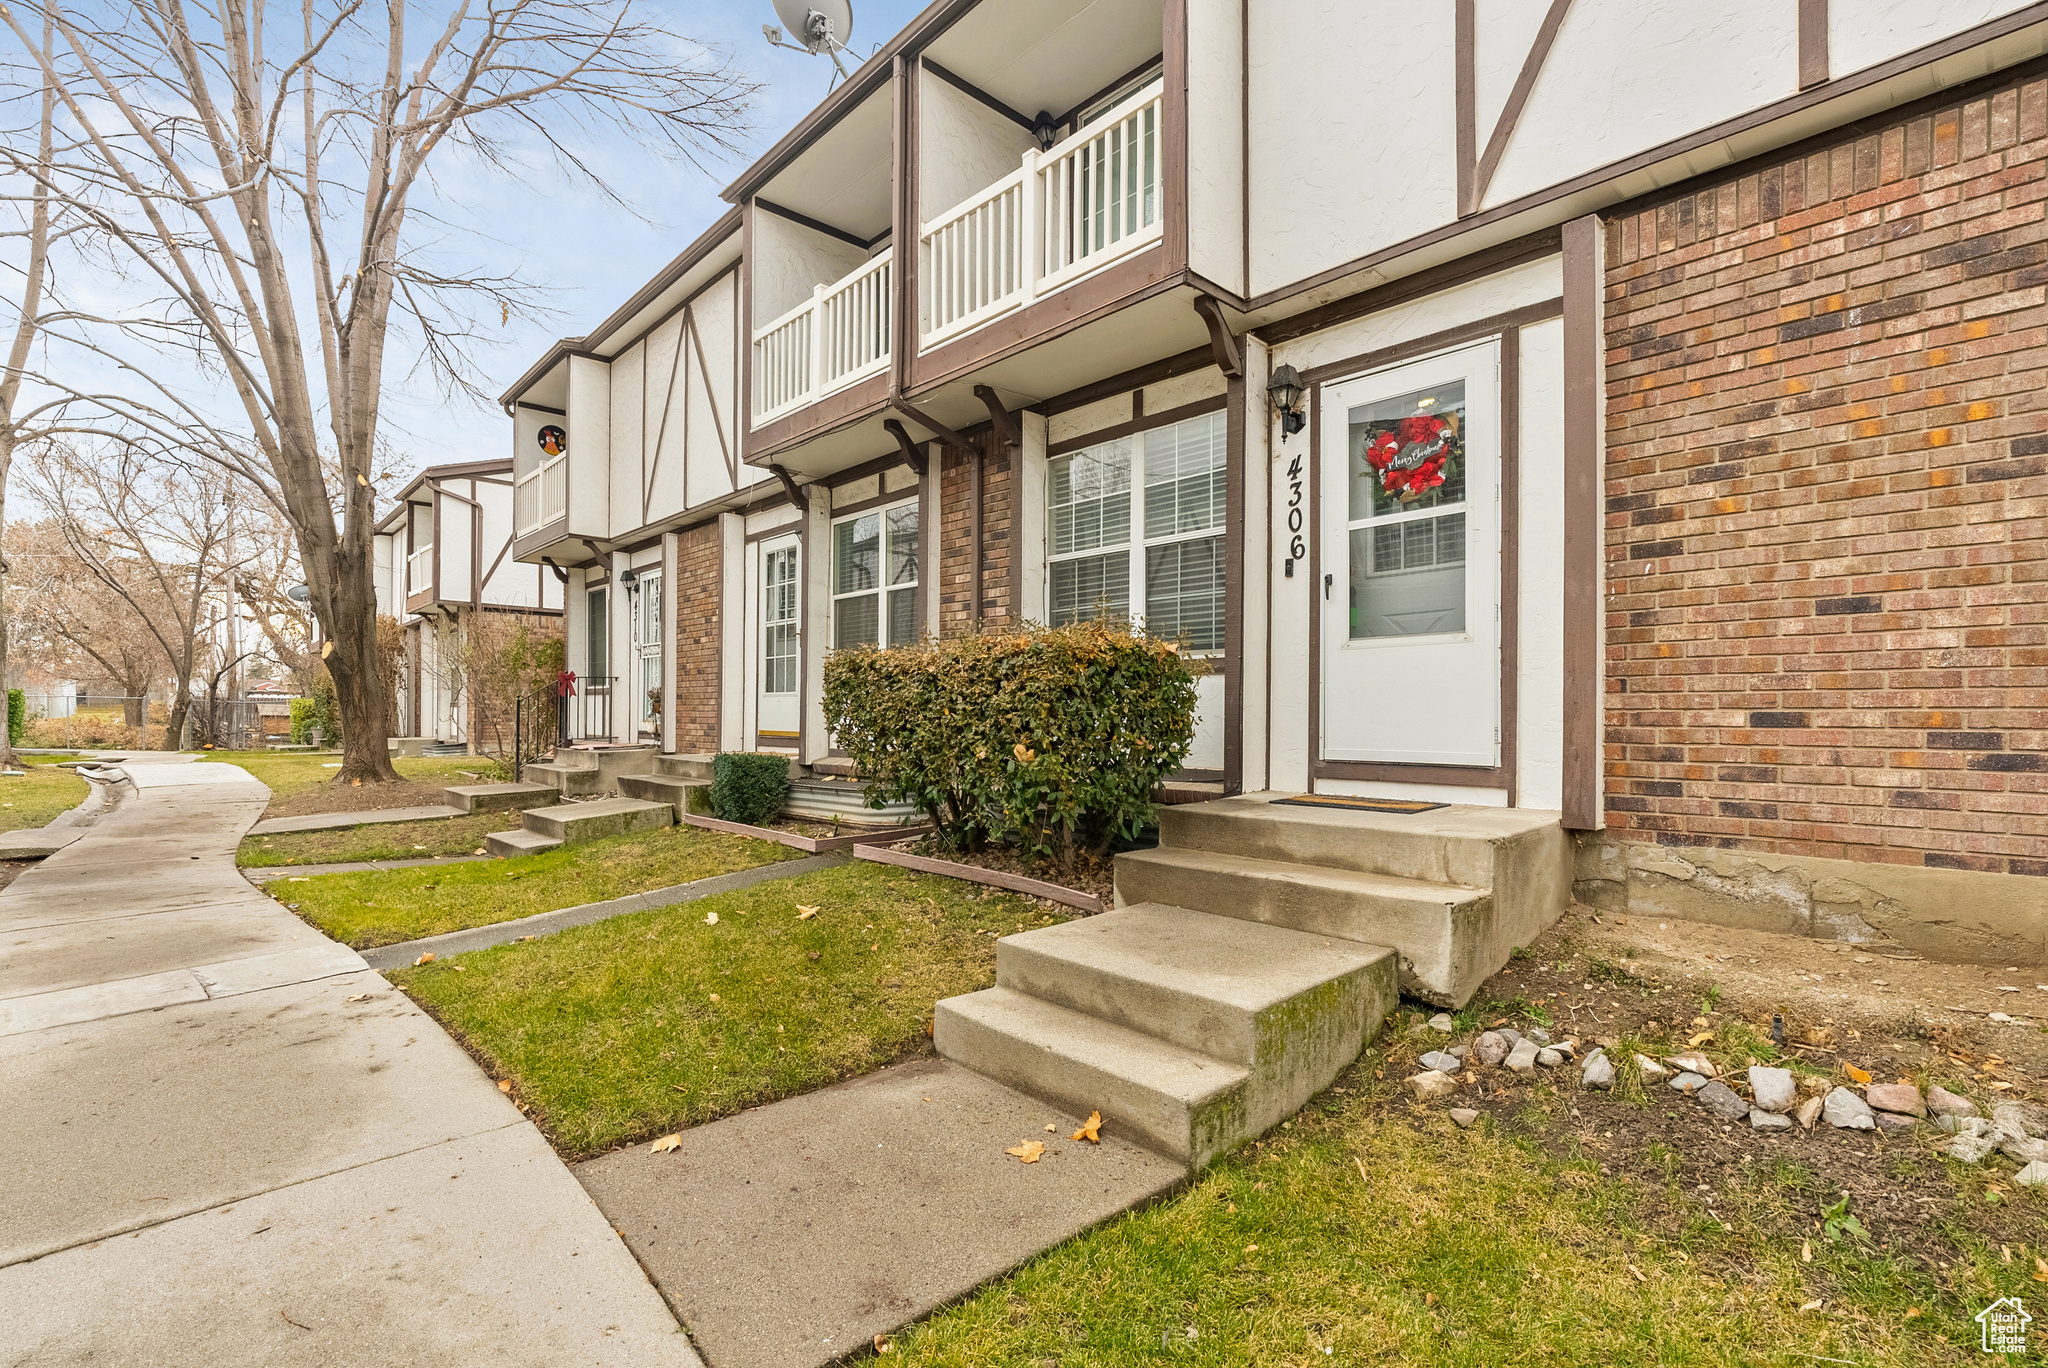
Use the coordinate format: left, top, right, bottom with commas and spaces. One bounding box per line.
0, 0, 752, 782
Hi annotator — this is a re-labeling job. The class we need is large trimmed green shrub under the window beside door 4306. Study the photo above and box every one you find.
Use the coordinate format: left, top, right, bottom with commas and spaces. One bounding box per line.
825, 621, 1196, 866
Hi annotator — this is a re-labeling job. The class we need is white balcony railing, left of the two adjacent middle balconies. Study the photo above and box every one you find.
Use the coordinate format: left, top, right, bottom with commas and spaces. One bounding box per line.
754, 250, 895, 422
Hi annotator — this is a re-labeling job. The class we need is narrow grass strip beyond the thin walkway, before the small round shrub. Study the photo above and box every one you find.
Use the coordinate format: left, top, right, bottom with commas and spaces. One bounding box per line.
268, 827, 799, 950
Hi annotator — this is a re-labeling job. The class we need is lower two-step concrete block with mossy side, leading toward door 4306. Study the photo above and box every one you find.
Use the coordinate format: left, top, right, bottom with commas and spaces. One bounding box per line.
932, 905, 1397, 1167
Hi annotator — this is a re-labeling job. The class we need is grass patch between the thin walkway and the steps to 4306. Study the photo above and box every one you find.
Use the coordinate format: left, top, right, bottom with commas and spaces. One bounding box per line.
393, 864, 1055, 1159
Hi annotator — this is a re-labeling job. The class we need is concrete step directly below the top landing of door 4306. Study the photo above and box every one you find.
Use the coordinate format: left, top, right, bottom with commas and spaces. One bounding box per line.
1116, 846, 1499, 1008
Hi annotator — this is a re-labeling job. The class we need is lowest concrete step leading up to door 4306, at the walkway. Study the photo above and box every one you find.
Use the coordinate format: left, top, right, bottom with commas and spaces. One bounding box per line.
932, 987, 1251, 1167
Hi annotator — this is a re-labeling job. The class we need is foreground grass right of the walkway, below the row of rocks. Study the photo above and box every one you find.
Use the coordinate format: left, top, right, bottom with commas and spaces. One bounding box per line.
889, 1055, 2042, 1368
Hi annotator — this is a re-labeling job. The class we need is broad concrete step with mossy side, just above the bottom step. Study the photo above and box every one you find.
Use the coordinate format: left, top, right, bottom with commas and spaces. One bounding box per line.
995, 903, 1399, 1073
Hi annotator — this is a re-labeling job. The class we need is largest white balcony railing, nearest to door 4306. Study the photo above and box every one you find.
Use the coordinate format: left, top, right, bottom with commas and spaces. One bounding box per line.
918, 80, 1165, 346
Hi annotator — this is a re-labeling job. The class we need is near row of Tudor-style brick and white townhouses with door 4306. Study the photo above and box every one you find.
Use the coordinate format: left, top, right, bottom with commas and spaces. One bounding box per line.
495, 0, 2048, 960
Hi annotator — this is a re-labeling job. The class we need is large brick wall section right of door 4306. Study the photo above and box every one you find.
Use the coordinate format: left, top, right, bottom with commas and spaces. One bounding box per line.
1606, 66, 2048, 874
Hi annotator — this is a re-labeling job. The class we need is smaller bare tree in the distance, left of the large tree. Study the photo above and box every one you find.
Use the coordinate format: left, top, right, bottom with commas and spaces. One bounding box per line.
29, 442, 244, 750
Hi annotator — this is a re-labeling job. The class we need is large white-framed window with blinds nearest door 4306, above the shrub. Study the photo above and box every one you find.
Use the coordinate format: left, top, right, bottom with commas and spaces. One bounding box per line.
1047, 414, 1225, 651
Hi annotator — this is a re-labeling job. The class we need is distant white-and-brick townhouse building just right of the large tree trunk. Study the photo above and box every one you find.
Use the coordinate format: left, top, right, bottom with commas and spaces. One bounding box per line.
375, 459, 565, 745
